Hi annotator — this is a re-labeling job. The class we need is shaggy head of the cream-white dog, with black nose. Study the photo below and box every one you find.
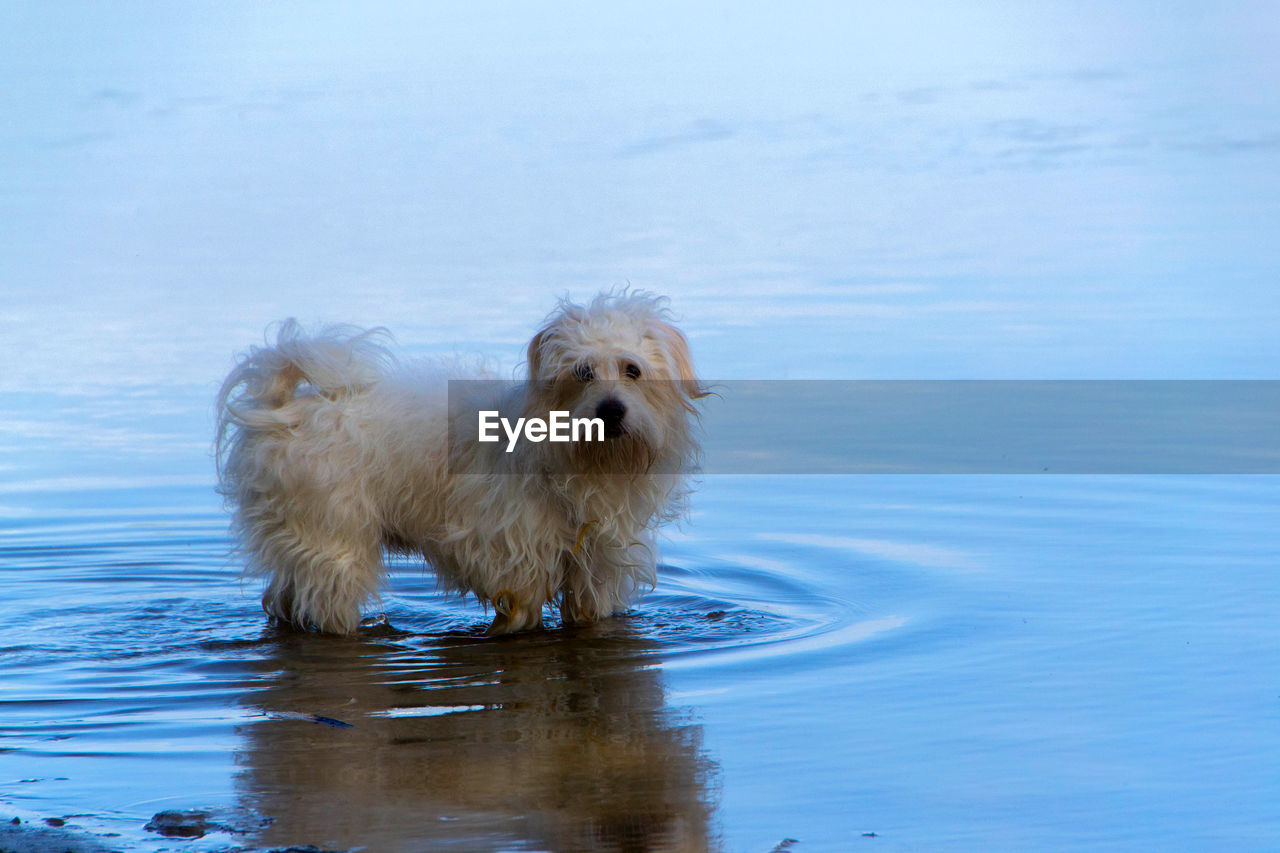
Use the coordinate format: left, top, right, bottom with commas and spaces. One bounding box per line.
529, 292, 707, 474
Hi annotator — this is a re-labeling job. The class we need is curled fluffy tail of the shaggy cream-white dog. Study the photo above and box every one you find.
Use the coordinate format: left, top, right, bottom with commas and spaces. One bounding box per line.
214, 318, 393, 481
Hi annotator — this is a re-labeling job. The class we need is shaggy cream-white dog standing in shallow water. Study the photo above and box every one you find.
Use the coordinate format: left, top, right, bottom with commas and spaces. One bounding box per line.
218, 293, 707, 634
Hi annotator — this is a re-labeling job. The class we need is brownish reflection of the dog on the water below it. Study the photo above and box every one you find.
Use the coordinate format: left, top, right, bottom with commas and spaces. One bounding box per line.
238, 621, 716, 852
